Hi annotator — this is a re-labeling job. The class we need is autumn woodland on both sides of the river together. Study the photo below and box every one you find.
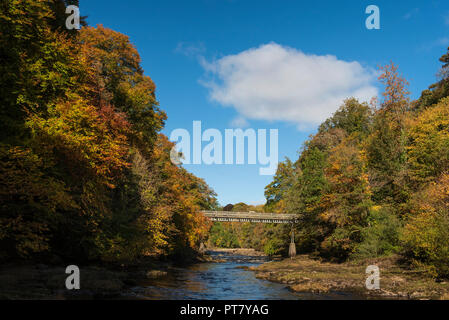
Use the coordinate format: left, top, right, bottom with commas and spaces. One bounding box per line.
0, 0, 449, 277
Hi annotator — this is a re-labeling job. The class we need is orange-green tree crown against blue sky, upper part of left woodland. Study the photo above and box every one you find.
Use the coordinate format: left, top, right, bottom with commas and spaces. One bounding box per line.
80, 25, 166, 154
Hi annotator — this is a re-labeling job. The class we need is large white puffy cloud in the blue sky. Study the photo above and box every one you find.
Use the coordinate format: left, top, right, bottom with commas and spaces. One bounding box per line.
200, 43, 377, 129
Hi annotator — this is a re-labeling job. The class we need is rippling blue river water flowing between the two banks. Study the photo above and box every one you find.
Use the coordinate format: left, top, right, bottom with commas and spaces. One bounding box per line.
124, 252, 364, 300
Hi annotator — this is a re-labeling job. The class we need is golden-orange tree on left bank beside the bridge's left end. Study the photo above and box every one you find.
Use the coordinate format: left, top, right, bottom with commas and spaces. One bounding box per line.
141, 134, 217, 256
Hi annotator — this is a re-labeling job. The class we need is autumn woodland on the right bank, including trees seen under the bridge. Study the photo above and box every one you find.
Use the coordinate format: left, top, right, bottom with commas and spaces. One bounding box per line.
210, 49, 449, 278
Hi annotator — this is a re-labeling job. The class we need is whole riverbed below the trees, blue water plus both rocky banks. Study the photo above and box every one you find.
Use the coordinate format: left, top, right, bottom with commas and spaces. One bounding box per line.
0, 249, 449, 299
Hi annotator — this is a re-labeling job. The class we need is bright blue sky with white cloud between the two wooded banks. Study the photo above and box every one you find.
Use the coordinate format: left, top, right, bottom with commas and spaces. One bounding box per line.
80, 0, 449, 205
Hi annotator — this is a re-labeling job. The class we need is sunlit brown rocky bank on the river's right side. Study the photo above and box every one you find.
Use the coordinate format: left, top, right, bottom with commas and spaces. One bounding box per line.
249, 255, 449, 299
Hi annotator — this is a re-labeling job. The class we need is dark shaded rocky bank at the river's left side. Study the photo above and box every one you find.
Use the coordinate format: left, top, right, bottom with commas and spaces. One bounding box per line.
0, 256, 206, 300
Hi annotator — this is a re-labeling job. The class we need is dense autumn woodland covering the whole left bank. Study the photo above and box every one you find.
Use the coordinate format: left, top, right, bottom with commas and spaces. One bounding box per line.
0, 0, 216, 262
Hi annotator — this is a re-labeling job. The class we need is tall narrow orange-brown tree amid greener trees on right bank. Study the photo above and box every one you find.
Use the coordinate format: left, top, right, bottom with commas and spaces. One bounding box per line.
319, 138, 371, 260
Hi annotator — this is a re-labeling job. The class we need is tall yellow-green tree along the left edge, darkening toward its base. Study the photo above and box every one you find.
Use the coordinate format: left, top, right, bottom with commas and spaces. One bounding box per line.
0, 0, 91, 256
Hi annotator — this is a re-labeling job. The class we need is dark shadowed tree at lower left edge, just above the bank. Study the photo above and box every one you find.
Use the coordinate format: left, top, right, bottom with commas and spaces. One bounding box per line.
0, 145, 77, 260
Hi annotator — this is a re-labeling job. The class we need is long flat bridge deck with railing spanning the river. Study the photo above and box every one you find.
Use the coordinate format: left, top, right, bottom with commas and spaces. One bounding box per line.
202, 211, 297, 223
